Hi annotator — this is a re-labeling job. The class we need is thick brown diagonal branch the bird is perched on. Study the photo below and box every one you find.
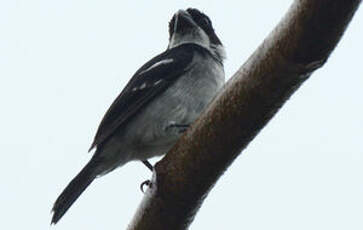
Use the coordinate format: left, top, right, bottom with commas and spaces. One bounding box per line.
129, 0, 361, 230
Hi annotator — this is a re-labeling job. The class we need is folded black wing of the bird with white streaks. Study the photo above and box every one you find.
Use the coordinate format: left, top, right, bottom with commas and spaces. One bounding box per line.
89, 45, 198, 151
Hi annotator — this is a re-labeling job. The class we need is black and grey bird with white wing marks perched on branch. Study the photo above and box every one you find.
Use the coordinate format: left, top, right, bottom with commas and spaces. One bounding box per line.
52, 8, 225, 224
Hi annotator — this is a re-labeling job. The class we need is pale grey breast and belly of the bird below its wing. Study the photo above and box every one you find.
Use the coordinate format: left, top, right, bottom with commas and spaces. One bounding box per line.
98, 56, 224, 173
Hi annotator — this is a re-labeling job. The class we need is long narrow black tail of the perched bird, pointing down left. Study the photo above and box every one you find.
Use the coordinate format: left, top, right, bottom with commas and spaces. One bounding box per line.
51, 160, 97, 224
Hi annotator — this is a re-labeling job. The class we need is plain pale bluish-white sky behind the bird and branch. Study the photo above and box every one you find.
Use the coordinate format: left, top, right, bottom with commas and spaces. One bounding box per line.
0, 0, 363, 230
